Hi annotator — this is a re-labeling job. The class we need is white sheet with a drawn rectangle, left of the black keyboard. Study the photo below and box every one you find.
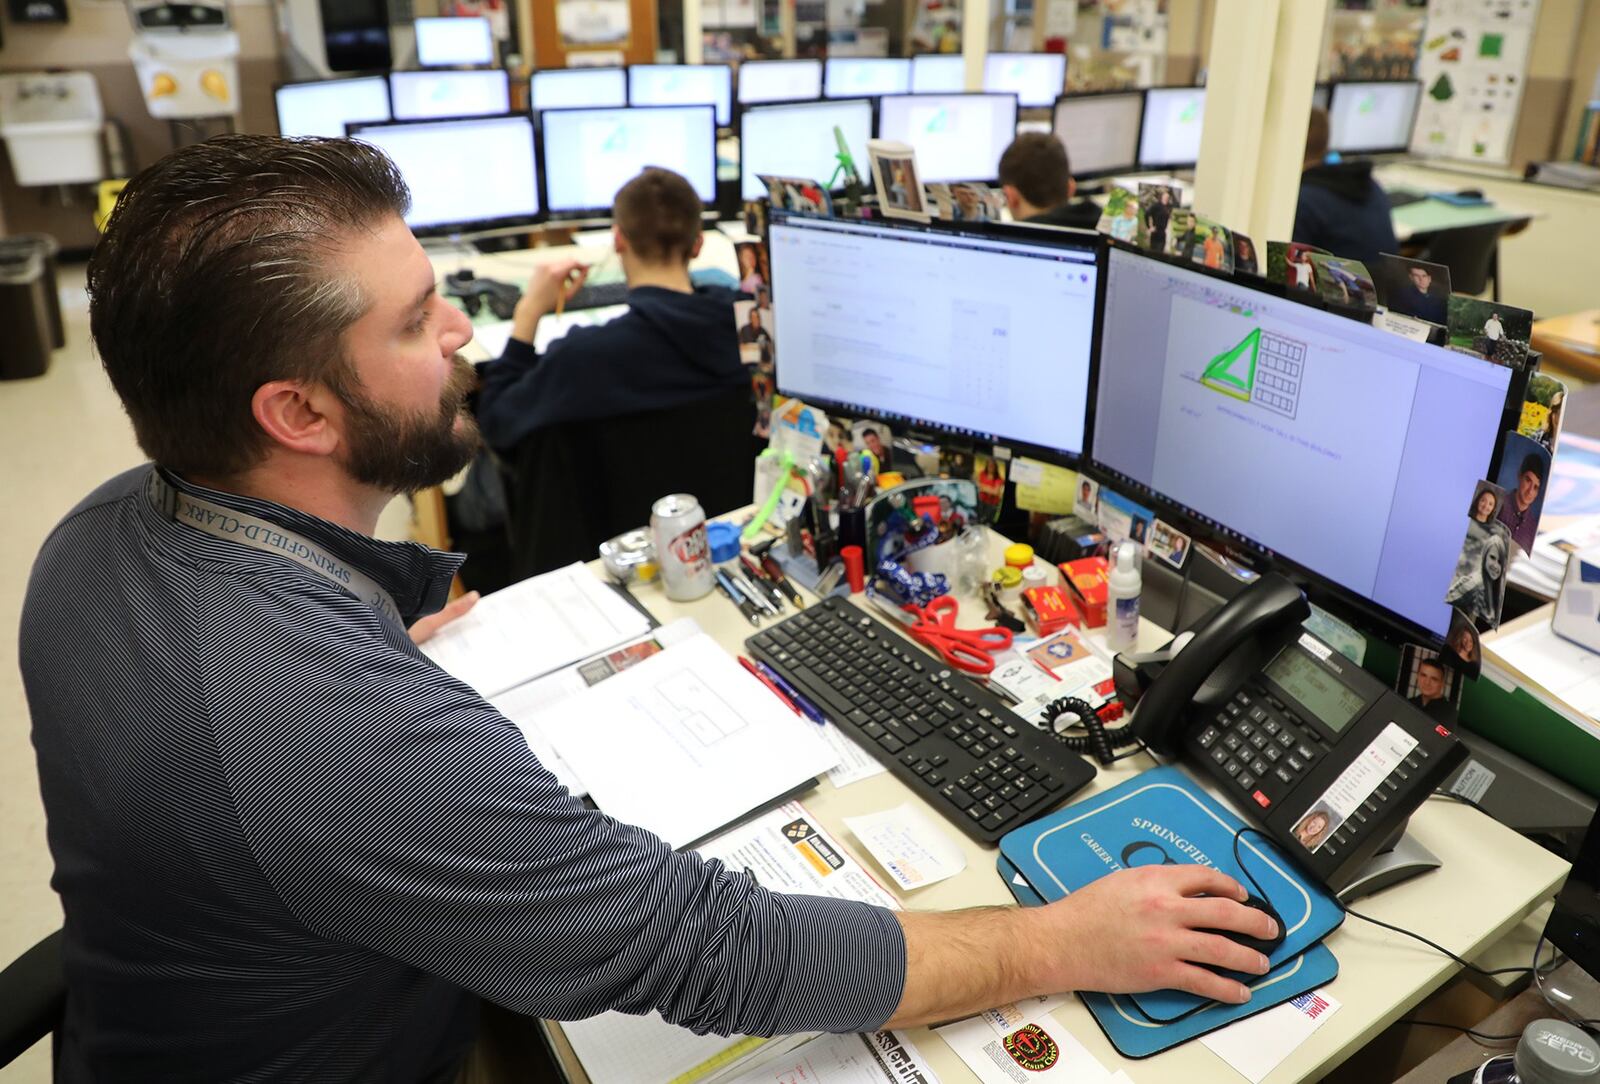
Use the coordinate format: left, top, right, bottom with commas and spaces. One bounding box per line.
537, 633, 838, 847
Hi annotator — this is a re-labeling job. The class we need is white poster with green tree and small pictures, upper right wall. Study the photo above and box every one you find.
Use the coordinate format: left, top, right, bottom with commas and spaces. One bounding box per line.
1411, 0, 1539, 165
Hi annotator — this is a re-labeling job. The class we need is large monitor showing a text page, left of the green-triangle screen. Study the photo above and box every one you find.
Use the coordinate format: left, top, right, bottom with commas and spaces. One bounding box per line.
768, 211, 1104, 457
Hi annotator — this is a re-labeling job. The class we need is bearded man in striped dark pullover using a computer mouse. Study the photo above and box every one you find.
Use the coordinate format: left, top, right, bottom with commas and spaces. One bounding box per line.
19, 134, 1274, 1084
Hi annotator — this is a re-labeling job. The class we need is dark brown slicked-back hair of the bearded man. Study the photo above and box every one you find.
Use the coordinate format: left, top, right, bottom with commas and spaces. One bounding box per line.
88, 136, 411, 476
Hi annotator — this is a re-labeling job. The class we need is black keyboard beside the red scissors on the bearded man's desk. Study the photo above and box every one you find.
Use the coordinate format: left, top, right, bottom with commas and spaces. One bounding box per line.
744, 598, 1094, 843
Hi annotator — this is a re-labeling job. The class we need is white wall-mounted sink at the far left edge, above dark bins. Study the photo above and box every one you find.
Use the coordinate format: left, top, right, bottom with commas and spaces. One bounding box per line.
0, 72, 106, 185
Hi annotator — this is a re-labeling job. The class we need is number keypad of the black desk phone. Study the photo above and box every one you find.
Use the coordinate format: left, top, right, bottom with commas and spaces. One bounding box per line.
1195, 683, 1331, 809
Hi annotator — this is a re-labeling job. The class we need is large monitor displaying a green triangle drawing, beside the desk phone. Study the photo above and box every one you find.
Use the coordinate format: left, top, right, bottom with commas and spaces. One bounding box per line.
1088, 248, 1512, 638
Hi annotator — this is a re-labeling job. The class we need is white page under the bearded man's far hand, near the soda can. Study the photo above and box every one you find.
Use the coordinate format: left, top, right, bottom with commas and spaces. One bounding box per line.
422, 564, 650, 697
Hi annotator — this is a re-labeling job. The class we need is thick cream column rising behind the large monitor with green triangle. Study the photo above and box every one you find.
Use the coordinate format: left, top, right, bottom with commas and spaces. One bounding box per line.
1195, 0, 1328, 248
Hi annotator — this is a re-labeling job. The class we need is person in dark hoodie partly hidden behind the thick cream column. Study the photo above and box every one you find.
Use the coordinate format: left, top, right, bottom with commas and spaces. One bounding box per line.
1294, 109, 1400, 269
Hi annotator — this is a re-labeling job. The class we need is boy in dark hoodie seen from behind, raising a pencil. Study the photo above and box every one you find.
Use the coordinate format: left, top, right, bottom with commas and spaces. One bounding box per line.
477, 168, 750, 451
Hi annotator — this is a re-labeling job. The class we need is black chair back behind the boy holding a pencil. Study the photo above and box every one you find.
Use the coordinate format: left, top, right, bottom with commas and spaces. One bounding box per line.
502, 387, 757, 584
